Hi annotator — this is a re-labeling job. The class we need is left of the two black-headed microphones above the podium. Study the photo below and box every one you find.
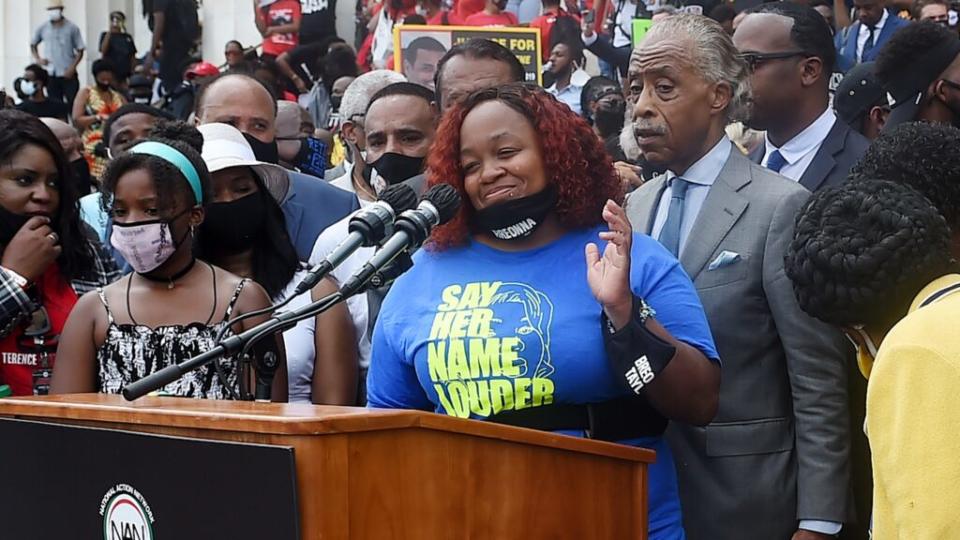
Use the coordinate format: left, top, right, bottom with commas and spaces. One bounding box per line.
290, 184, 417, 298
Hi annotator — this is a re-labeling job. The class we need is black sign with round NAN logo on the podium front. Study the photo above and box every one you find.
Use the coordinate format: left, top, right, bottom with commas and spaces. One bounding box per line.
0, 419, 300, 540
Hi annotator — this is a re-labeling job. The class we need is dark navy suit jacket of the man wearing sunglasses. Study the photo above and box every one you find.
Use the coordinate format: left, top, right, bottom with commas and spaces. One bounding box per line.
750, 118, 870, 191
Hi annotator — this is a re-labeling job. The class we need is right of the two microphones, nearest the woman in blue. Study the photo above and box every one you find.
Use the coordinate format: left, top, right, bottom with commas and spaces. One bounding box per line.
340, 184, 460, 298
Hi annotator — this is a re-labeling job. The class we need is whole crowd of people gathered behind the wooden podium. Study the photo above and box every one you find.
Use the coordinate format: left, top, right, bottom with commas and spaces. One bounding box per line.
0, 0, 960, 540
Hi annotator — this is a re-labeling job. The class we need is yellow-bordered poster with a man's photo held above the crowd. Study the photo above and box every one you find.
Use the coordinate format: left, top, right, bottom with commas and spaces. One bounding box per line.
393, 24, 542, 91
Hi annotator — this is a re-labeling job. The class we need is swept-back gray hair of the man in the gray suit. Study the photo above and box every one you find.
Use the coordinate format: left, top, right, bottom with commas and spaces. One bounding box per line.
641, 13, 750, 121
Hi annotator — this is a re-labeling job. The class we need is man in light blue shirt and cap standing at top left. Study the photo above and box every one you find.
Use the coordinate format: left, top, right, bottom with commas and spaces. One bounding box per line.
30, 0, 86, 109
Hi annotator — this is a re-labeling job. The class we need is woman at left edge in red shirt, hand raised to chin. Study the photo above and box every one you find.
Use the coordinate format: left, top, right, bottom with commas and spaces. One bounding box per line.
0, 110, 120, 395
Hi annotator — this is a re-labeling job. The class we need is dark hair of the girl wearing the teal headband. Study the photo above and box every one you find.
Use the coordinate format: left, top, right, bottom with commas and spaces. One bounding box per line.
100, 121, 211, 216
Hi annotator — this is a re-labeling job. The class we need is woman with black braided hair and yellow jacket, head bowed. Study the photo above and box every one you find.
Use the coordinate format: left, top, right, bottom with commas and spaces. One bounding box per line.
786, 180, 960, 539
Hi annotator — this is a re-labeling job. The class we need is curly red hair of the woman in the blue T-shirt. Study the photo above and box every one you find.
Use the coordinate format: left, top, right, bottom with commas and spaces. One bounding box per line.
427, 84, 623, 250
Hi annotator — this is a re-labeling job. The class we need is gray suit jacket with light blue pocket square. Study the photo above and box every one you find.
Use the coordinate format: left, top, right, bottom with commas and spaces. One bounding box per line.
626, 148, 852, 540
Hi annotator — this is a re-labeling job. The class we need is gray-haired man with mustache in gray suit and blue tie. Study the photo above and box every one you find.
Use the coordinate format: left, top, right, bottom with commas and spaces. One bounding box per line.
623, 15, 851, 540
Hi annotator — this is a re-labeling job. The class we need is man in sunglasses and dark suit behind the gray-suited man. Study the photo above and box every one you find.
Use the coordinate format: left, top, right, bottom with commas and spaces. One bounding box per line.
733, 2, 870, 191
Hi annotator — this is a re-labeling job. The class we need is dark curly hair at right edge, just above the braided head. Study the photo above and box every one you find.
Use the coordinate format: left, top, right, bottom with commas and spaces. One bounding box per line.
850, 122, 960, 232
